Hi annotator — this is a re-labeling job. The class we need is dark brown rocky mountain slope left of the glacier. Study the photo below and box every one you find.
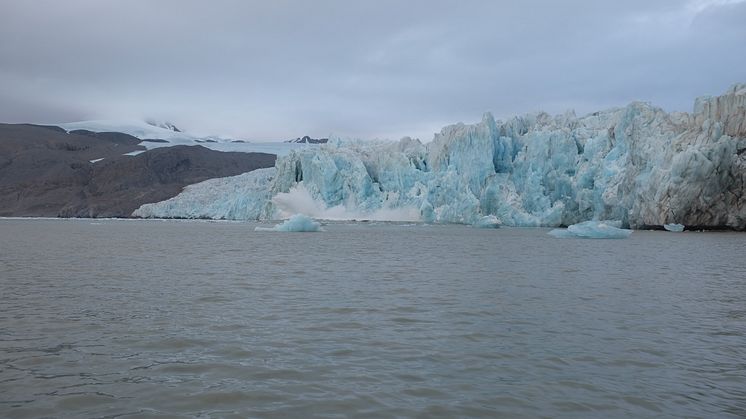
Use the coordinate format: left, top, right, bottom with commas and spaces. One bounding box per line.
0, 124, 276, 217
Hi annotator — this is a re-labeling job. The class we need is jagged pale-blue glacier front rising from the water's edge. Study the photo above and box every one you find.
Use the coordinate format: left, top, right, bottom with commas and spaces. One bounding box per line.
134, 84, 746, 230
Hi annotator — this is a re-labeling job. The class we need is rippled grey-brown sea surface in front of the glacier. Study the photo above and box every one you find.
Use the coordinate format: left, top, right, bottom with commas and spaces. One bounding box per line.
0, 219, 746, 418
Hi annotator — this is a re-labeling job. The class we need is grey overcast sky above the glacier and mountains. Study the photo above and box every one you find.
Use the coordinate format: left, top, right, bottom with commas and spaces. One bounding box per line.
0, 0, 746, 141
